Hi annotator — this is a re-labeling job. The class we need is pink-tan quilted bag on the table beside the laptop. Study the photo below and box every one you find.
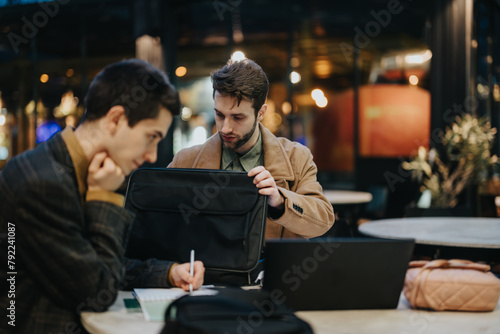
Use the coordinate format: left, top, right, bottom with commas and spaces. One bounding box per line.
403, 260, 500, 311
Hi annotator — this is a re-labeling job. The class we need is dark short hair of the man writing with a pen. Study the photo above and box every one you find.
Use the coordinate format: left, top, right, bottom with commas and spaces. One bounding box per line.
82, 59, 180, 127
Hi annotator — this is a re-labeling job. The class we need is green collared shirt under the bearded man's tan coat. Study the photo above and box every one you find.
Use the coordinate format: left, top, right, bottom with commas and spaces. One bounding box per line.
221, 133, 264, 173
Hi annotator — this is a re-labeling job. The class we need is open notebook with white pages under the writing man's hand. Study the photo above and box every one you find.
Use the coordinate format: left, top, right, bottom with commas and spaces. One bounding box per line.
134, 287, 218, 321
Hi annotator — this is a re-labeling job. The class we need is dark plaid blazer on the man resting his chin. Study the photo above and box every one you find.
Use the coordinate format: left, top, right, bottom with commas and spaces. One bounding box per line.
0, 134, 133, 334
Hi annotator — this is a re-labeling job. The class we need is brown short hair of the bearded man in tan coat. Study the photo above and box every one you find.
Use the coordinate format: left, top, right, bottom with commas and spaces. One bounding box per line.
211, 59, 269, 115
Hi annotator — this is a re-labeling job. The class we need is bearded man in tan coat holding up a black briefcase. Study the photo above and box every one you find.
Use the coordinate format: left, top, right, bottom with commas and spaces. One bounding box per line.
169, 59, 334, 239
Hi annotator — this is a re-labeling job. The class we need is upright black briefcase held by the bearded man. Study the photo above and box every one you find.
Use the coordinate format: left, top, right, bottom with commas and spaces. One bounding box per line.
125, 168, 267, 283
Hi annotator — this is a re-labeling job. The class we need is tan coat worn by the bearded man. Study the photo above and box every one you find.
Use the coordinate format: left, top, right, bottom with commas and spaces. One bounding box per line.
168, 123, 334, 239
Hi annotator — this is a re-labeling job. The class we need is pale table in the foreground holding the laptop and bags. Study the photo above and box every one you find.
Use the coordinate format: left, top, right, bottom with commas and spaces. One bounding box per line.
81, 291, 500, 334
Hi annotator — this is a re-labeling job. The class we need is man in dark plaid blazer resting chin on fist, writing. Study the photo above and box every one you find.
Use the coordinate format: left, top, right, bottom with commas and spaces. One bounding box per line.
0, 60, 204, 334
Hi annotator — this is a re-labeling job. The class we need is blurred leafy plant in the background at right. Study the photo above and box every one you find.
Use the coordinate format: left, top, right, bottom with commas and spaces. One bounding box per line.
402, 114, 498, 215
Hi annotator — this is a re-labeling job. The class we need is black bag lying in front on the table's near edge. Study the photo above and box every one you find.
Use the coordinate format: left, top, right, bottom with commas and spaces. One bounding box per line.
161, 287, 313, 334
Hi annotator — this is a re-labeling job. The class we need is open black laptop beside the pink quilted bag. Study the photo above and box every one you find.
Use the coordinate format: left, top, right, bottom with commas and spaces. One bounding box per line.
263, 238, 414, 311
